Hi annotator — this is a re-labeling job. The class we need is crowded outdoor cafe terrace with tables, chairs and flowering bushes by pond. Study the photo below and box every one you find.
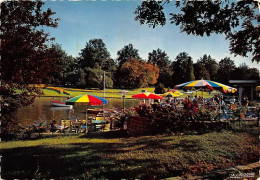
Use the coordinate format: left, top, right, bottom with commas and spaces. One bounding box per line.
18, 95, 260, 138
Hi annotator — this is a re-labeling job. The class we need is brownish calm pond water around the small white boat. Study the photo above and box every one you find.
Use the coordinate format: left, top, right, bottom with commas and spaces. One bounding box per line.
16, 97, 140, 126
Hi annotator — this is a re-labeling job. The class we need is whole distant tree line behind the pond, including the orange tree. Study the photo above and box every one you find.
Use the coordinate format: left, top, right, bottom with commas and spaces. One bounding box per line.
53, 39, 259, 89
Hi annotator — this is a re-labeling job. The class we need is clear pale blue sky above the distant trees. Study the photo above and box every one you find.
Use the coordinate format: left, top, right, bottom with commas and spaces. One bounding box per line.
44, 0, 260, 70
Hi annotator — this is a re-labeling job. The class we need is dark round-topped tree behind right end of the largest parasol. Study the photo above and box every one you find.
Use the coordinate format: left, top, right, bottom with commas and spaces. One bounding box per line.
217, 57, 236, 84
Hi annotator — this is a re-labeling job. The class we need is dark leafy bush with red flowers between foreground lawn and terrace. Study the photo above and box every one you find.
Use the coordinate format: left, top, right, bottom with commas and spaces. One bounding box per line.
135, 104, 231, 134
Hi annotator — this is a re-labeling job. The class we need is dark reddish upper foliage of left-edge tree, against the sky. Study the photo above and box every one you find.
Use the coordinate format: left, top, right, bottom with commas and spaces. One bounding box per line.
0, 1, 57, 84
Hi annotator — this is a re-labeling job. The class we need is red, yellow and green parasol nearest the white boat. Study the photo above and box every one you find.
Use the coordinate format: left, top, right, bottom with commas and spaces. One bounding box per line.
66, 94, 108, 106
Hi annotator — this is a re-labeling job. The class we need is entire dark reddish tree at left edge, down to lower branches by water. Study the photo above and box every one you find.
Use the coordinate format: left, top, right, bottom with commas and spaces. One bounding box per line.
0, 1, 59, 135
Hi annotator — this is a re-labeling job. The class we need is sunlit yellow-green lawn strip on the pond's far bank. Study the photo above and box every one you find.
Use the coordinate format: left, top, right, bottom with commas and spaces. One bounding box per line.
39, 88, 212, 98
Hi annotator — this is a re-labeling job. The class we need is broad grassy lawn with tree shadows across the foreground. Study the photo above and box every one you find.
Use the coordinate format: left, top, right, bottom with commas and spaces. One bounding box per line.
0, 122, 259, 179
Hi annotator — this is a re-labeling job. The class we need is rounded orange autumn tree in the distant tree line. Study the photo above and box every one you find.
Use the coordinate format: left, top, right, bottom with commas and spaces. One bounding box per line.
119, 58, 159, 88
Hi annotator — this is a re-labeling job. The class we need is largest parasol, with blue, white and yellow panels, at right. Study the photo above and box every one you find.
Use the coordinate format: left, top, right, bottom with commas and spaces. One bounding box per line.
174, 80, 237, 93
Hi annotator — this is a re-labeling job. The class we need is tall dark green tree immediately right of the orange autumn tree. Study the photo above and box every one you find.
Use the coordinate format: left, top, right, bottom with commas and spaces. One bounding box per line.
148, 48, 173, 87
